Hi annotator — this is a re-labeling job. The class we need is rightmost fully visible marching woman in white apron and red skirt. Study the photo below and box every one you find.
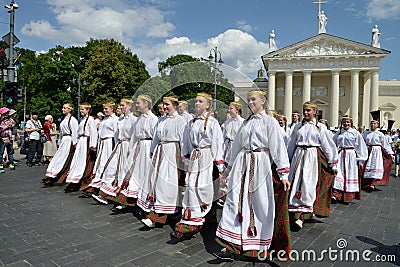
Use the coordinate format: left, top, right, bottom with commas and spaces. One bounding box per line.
361, 118, 394, 192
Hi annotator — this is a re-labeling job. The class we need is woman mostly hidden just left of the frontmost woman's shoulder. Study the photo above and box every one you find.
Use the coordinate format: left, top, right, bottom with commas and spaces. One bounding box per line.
218, 102, 244, 206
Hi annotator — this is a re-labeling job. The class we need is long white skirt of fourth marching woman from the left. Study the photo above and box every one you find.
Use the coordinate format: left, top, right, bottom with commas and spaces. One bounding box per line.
100, 141, 129, 197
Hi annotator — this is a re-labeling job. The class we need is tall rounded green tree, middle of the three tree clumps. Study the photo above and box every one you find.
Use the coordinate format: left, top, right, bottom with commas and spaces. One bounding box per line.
82, 39, 150, 109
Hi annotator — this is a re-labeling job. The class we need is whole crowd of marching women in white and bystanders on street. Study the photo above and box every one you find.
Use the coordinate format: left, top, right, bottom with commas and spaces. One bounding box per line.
0, 90, 392, 261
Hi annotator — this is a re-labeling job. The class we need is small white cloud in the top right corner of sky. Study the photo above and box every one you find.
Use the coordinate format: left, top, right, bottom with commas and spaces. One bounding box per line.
365, 0, 400, 20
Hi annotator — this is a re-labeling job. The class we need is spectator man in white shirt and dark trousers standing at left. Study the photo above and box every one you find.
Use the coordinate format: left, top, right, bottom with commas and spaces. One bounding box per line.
25, 110, 43, 167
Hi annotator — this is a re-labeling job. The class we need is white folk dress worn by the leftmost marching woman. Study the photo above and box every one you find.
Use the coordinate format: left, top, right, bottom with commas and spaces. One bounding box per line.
46, 114, 78, 183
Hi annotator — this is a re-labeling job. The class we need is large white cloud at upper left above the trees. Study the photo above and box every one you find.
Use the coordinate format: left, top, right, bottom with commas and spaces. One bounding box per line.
22, 0, 175, 44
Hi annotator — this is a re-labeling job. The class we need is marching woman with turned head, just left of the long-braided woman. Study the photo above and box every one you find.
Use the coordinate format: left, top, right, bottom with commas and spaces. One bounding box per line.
137, 96, 186, 228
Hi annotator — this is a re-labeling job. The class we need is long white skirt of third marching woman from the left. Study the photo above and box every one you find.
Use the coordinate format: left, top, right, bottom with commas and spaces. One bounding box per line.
89, 138, 113, 188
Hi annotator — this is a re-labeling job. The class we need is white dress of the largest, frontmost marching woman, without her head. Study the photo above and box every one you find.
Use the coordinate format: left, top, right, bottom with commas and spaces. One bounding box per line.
216, 111, 289, 252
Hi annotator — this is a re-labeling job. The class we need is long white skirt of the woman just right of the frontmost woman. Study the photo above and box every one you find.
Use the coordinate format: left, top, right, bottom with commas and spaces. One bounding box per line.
289, 147, 318, 212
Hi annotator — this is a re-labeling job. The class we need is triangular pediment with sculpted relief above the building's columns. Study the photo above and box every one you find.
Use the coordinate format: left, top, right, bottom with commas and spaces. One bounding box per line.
263, 33, 390, 58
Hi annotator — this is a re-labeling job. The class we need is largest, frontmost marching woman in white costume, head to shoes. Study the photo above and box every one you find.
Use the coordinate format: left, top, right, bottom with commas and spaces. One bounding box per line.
213, 90, 290, 261
